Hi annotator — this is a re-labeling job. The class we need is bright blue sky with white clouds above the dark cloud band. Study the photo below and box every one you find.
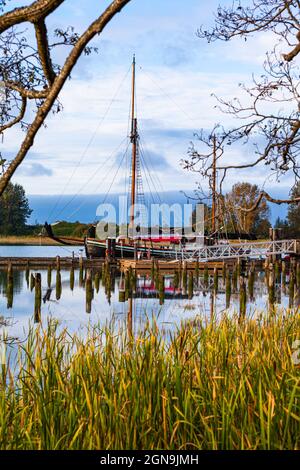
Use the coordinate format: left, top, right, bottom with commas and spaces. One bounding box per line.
2, 0, 294, 200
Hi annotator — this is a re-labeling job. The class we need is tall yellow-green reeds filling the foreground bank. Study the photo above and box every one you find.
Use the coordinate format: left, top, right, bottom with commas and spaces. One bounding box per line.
0, 311, 300, 449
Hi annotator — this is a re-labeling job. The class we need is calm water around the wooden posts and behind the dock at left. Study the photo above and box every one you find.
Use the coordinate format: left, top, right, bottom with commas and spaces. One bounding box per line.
0, 246, 296, 339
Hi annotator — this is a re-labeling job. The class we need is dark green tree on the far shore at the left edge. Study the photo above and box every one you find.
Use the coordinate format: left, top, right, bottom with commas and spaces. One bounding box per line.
0, 183, 32, 235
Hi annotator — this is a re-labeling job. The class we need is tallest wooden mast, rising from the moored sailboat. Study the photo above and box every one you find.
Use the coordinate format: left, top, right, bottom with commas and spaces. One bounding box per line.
129, 55, 138, 228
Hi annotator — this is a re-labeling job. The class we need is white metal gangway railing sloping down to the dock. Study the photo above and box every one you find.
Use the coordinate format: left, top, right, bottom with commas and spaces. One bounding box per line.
177, 240, 299, 261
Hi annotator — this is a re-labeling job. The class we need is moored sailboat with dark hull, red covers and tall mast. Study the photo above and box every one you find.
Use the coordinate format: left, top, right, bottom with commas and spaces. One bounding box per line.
85, 56, 182, 259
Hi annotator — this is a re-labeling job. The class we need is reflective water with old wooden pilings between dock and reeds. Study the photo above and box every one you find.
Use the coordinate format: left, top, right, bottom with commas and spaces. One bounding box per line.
0, 265, 300, 342
